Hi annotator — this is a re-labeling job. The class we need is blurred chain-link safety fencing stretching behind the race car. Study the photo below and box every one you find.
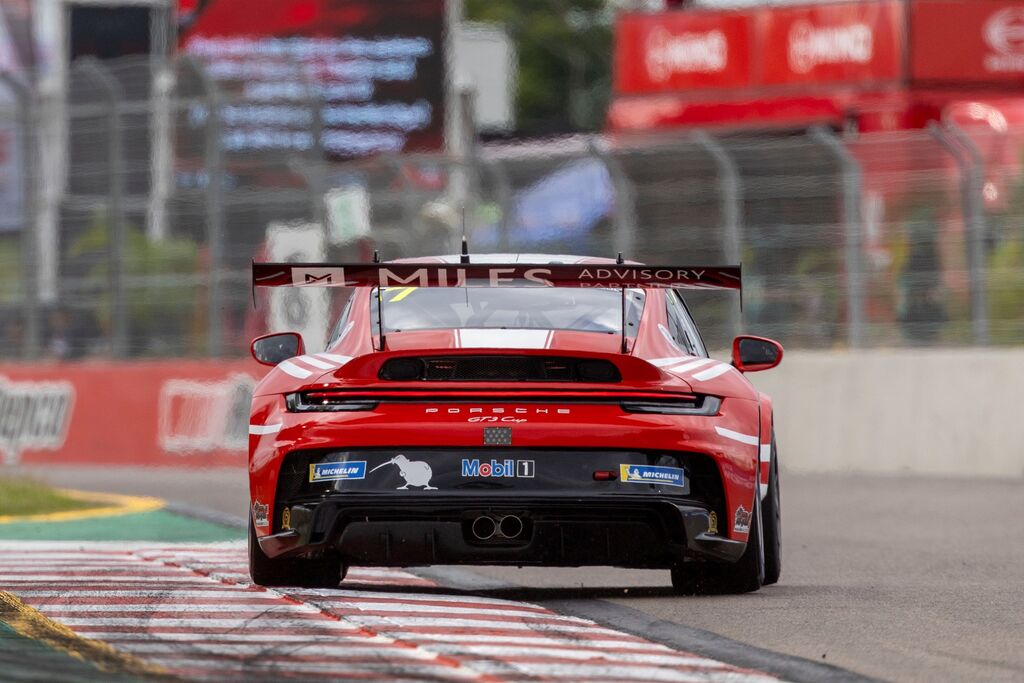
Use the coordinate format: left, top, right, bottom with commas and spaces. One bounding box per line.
0, 58, 1024, 358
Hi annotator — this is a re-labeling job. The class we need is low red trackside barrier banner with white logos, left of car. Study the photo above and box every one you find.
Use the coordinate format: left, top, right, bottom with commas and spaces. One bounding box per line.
0, 360, 266, 467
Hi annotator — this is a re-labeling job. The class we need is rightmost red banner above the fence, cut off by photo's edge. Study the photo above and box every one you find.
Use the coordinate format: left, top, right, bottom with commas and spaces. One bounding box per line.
910, 0, 1024, 84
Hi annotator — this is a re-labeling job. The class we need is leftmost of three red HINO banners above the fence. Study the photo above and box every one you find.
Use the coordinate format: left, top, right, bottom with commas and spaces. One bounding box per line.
614, 12, 752, 94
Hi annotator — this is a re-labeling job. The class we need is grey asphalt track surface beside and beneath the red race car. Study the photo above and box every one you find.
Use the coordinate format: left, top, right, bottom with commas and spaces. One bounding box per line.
14, 467, 1024, 681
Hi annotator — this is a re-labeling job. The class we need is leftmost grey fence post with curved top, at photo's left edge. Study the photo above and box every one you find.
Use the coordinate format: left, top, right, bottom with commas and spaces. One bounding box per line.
0, 74, 42, 360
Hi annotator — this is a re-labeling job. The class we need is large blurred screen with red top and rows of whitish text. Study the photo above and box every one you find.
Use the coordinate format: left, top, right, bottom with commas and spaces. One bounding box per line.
179, 0, 444, 159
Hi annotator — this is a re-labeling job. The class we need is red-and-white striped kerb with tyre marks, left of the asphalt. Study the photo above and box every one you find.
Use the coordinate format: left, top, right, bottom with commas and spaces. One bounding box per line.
0, 541, 798, 683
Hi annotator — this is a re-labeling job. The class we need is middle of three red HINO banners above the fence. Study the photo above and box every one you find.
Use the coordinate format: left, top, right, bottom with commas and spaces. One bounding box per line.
758, 0, 906, 85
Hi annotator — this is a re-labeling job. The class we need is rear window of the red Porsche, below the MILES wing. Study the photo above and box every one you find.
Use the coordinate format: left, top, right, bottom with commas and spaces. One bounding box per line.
370, 287, 645, 336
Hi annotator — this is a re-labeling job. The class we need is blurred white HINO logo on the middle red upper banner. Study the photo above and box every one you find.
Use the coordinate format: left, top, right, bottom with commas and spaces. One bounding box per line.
788, 20, 874, 74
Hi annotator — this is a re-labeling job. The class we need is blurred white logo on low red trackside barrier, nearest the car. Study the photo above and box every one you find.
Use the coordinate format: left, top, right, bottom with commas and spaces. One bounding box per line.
157, 373, 258, 454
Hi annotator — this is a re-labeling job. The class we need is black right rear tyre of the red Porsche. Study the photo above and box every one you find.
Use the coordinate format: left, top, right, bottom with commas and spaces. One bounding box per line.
672, 486, 765, 595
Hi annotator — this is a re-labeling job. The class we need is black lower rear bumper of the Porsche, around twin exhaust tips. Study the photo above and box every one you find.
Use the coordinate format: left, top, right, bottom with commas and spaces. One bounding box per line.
259, 494, 745, 568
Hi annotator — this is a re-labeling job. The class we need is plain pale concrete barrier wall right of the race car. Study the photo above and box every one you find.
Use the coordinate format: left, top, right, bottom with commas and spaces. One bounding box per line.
750, 349, 1024, 477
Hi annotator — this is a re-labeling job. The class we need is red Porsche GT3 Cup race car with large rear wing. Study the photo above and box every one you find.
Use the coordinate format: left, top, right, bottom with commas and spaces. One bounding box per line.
249, 254, 782, 593
